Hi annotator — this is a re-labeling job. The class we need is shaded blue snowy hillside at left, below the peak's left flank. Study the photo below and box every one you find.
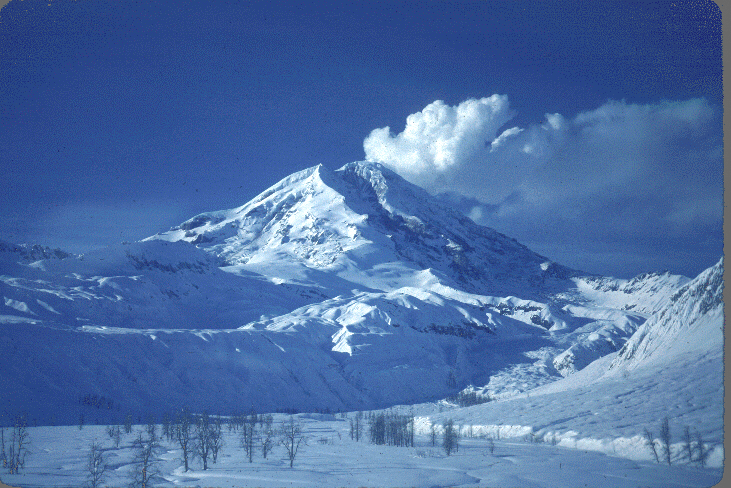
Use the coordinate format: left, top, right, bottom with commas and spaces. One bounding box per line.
0, 241, 324, 329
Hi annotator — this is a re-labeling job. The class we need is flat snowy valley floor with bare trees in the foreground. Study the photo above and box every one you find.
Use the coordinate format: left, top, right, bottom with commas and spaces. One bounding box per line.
2, 414, 722, 487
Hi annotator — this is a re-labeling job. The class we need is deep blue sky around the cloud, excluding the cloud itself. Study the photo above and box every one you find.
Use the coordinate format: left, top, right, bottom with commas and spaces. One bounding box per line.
0, 0, 723, 276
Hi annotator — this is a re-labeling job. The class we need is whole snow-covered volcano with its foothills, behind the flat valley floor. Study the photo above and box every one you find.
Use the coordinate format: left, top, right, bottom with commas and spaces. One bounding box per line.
0, 162, 716, 430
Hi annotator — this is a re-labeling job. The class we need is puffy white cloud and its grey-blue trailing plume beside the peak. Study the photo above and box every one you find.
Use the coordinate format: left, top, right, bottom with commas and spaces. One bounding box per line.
364, 95, 723, 278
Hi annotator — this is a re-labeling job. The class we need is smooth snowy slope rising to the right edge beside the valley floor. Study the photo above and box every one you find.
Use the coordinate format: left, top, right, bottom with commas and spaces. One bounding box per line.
418, 259, 724, 467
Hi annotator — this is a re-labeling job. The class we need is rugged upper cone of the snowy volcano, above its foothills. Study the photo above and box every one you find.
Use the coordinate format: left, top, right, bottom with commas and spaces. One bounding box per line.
150, 162, 575, 293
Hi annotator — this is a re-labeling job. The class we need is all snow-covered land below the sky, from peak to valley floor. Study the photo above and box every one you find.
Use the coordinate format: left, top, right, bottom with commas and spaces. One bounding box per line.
0, 163, 724, 486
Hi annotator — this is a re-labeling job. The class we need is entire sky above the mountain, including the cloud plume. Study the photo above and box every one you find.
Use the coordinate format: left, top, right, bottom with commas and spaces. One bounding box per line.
0, 0, 723, 276
